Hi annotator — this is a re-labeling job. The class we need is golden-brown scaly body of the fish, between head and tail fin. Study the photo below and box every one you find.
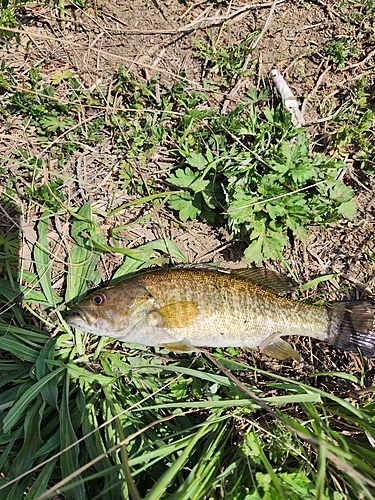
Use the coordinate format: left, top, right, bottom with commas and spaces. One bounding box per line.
139, 269, 328, 348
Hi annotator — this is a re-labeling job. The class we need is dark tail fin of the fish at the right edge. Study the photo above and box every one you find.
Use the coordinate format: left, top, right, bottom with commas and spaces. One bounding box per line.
326, 300, 375, 358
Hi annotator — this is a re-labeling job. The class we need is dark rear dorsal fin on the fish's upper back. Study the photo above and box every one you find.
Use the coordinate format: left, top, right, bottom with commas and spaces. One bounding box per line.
231, 267, 298, 295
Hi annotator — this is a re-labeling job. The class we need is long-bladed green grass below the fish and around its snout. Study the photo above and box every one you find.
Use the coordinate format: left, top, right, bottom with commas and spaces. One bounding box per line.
0, 198, 375, 500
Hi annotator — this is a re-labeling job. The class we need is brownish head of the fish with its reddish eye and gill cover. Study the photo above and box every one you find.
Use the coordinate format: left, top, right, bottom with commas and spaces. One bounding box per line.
66, 283, 155, 338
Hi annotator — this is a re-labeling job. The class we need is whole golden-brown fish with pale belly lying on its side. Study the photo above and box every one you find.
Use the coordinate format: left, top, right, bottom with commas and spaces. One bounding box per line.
67, 265, 375, 361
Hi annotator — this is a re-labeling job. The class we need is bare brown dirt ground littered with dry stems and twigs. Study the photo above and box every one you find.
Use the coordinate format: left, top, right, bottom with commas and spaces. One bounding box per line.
0, 0, 375, 397
